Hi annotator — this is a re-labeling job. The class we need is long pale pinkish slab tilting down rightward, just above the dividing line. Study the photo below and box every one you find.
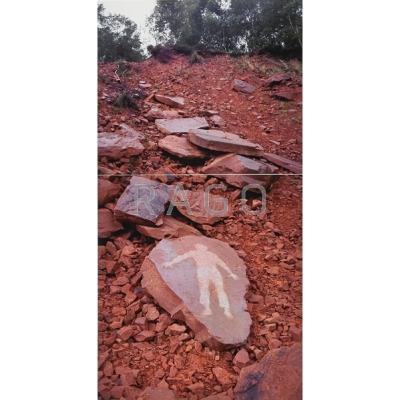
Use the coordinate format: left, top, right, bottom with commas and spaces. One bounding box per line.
188, 129, 264, 157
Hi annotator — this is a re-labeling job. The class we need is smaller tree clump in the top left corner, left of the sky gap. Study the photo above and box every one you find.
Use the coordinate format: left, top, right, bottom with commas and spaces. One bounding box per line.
97, 4, 143, 61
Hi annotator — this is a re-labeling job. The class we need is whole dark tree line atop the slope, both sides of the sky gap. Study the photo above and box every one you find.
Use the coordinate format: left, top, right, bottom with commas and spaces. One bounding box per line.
98, 0, 302, 61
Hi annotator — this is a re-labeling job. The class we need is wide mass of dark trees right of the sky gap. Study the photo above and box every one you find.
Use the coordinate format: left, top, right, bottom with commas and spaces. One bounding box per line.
149, 0, 302, 55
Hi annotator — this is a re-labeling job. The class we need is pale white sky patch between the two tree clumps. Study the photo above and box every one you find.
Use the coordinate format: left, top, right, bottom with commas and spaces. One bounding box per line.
100, 0, 156, 48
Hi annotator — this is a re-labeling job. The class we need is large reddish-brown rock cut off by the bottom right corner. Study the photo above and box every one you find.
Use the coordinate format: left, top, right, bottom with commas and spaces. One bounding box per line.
235, 344, 302, 400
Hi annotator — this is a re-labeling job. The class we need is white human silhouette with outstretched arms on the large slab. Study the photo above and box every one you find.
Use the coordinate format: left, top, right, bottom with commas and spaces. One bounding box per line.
164, 244, 239, 318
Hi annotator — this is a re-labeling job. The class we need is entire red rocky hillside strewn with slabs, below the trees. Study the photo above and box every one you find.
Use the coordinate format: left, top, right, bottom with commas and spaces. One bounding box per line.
98, 55, 302, 400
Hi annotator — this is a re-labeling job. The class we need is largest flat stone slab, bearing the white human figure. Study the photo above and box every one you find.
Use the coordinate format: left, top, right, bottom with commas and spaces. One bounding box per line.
142, 236, 251, 348
